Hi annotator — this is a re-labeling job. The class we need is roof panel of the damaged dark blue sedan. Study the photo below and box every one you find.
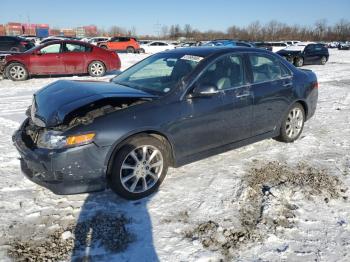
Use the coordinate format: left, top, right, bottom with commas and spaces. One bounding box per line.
161, 46, 271, 57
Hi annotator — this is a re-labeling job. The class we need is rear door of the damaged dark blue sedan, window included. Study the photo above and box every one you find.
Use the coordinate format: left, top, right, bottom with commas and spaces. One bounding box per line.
248, 53, 293, 136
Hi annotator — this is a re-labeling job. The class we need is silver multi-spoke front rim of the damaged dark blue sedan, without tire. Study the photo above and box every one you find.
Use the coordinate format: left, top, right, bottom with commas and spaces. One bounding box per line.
120, 145, 164, 193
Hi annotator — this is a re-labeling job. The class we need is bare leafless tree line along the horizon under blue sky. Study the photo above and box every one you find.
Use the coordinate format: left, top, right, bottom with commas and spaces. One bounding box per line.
101, 19, 350, 41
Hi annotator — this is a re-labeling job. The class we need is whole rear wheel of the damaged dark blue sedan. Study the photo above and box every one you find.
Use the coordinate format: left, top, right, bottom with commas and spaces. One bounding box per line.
276, 103, 305, 143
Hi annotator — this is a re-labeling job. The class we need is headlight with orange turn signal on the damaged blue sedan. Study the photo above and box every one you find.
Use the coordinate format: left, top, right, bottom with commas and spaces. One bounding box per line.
37, 131, 95, 149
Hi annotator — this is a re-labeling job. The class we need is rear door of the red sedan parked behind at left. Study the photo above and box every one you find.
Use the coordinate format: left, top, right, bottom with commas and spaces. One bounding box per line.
62, 43, 90, 74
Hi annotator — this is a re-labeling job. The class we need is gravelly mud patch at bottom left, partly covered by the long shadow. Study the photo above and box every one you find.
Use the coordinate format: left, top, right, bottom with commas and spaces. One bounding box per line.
7, 213, 134, 261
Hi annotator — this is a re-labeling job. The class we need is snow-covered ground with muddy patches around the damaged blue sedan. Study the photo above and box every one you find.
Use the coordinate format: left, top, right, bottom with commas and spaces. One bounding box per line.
0, 50, 350, 261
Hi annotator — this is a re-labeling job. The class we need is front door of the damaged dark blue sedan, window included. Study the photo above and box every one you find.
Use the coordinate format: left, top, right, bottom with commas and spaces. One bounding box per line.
175, 55, 252, 156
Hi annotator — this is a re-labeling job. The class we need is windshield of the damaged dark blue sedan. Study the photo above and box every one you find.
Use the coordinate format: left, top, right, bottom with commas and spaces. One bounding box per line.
112, 53, 203, 95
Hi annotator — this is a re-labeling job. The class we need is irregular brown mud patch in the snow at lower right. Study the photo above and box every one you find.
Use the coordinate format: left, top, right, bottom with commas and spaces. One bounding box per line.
184, 162, 347, 258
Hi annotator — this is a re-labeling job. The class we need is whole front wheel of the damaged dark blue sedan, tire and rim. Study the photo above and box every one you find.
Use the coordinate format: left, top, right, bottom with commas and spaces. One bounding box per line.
109, 135, 169, 200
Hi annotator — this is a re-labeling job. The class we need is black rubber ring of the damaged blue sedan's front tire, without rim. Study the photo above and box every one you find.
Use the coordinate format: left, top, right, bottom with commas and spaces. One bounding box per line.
108, 135, 169, 200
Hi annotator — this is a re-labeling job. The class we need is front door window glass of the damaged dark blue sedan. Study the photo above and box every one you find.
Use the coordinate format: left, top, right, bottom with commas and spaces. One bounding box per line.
197, 55, 244, 90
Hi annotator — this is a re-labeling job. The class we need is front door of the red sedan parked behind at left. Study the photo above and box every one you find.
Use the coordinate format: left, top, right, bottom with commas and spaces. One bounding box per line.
30, 43, 65, 75
